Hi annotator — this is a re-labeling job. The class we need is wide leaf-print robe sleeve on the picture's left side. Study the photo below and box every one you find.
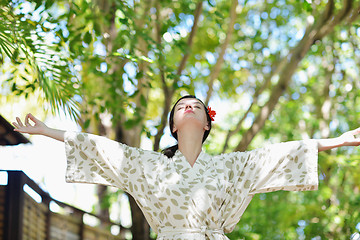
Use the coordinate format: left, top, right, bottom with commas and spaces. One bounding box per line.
64, 132, 144, 191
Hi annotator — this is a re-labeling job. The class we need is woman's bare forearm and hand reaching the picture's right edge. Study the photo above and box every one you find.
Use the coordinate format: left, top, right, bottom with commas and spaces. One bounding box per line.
317, 128, 360, 152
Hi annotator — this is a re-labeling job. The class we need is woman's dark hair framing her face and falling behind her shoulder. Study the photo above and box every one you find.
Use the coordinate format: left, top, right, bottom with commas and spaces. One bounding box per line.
162, 95, 211, 158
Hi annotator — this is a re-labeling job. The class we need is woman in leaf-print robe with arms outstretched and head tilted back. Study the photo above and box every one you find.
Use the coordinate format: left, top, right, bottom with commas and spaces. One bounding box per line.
14, 96, 360, 239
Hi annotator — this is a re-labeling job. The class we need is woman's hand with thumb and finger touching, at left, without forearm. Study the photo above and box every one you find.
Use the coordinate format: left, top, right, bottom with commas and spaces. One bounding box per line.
13, 113, 48, 135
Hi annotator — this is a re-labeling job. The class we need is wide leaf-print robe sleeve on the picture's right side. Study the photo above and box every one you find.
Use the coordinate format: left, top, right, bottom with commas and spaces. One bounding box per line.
231, 140, 318, 194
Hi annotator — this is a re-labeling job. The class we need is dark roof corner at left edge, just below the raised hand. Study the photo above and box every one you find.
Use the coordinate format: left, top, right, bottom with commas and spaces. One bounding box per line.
0, 115, 30, 146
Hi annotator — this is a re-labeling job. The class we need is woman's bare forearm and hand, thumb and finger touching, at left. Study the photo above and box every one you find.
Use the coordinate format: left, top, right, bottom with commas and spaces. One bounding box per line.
13, 113, 65, 142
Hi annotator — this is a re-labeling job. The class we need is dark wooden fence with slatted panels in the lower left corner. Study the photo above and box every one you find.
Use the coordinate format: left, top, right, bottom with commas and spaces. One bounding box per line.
0, 170, 130, 240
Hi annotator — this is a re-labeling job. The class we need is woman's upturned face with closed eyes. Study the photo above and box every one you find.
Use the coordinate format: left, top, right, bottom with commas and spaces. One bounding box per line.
172, 98, 209, 135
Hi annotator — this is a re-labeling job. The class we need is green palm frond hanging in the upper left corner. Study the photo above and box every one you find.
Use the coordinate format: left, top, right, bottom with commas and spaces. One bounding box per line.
0, 3, 79, 119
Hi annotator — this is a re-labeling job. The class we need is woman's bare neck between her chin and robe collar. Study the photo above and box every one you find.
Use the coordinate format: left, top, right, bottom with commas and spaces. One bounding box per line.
177, 129, 204, 166
